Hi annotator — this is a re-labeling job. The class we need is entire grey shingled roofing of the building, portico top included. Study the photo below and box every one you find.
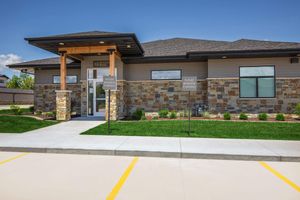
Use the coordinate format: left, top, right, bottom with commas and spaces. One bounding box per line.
9, 36, 300, 67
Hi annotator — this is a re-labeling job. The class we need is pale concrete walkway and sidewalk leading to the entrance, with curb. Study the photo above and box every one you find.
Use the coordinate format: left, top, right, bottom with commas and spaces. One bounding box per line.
0, 119, 300, 162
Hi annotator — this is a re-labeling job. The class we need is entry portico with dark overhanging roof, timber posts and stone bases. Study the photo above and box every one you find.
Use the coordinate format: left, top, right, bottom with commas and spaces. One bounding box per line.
26, 31, 143, 120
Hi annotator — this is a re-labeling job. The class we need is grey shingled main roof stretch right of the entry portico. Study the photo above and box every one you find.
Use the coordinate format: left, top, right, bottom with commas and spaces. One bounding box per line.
142, 38, 300, 57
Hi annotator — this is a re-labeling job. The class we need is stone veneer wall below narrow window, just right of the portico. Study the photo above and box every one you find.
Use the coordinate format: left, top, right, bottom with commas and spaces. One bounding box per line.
123, 80, 207, 115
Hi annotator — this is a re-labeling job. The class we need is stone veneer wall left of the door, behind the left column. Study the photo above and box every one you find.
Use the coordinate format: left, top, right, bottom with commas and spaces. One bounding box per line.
34, 84, 81, 114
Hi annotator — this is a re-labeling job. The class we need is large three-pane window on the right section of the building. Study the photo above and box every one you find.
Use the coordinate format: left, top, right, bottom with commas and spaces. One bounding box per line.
240, 66, 275, 98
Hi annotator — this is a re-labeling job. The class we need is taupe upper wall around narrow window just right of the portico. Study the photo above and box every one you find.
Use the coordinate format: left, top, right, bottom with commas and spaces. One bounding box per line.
124, 62, 207, 81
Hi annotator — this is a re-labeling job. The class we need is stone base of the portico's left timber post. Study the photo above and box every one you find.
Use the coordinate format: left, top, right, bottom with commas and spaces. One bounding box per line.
55, 90, 72, 121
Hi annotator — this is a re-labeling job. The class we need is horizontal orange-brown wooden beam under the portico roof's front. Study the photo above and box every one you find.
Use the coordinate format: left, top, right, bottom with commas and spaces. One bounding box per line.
58, 45, 117, 54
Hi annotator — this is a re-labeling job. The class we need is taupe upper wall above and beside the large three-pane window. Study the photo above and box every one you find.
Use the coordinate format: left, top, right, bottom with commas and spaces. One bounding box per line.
208, 57, 300, 78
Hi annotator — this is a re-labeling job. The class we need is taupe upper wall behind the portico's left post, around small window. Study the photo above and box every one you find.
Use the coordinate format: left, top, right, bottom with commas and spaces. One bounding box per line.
34, 68, 80, 85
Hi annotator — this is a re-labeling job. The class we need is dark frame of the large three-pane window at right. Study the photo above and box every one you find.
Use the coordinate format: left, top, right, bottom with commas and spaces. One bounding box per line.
239, 65, 276, 99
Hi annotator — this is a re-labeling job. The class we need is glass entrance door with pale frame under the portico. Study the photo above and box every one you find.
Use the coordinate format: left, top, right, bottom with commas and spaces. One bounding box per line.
93, 80, 105, 117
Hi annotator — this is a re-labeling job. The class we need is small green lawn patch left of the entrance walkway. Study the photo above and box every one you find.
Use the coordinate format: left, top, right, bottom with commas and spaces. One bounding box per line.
0, 116, 58, 133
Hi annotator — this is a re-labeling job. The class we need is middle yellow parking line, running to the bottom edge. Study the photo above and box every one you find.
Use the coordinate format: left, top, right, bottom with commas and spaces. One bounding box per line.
106, 157, 139, 200
